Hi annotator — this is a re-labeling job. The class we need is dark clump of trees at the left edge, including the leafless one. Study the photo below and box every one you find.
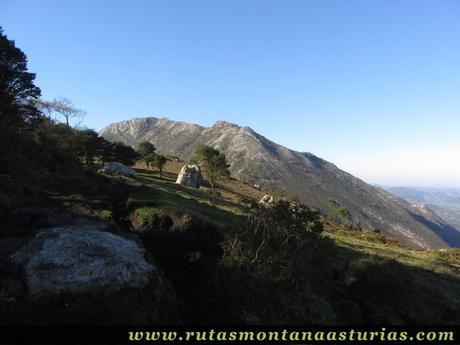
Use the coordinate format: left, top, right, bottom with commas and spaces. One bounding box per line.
0, 29, 137, 188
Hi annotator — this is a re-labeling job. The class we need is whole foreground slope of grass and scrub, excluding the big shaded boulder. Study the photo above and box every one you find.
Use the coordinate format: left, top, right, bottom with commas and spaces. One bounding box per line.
0, 161, 460, 324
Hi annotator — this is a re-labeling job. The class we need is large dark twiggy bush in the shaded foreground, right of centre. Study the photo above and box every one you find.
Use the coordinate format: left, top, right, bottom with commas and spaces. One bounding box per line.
221, 201, 334, 323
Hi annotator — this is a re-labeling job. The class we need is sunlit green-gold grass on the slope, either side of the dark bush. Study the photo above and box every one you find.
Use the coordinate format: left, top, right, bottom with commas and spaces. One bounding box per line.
128, 160, 460, 277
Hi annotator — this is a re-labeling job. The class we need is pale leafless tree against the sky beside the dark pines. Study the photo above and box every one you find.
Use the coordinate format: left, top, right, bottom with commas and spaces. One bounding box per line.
36, 97, 86, 128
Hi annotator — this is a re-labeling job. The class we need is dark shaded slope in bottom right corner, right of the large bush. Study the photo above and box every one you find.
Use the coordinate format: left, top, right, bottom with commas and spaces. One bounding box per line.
328, 242, 460, 325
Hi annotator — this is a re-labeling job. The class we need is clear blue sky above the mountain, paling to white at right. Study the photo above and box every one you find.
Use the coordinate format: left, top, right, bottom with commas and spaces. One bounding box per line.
0, 0, 460, 186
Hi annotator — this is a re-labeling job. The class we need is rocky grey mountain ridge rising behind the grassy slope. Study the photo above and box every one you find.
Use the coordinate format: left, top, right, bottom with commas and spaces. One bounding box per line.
100, 117, 460, 248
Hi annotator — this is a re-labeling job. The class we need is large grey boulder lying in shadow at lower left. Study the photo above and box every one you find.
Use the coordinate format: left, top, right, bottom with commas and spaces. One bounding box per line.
11, 227, 158, 296
